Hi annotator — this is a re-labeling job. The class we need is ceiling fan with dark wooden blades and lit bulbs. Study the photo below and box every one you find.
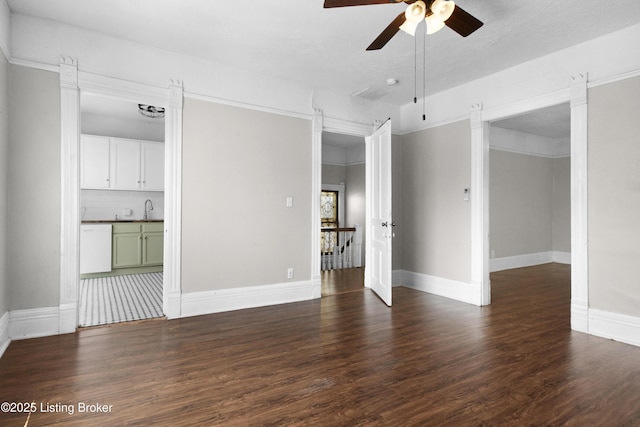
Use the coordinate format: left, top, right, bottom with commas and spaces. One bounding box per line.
324, 0, 482, 50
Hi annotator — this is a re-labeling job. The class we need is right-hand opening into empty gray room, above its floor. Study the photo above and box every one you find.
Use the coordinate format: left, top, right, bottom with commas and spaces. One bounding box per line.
489, 103, 571, 294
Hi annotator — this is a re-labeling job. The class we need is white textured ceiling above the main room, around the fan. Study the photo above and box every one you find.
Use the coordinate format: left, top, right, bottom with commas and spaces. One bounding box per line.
8, 0, 640, 105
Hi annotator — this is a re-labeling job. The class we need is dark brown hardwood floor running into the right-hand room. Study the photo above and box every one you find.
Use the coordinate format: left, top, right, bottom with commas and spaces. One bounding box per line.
0, 264, 640, 426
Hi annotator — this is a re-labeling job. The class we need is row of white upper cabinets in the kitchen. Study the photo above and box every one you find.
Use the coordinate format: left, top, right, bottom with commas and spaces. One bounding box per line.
80, 135, 164, 191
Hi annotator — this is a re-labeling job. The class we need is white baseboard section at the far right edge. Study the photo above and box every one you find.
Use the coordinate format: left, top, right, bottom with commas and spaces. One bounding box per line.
588, 308, 640, 346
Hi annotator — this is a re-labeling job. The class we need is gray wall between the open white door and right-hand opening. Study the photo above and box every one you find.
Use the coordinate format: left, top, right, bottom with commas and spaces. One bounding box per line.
394, 120, 471, 283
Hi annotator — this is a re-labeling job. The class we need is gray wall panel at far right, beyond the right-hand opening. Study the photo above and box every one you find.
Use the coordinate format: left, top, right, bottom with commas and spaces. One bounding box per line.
588, 77, 640, 316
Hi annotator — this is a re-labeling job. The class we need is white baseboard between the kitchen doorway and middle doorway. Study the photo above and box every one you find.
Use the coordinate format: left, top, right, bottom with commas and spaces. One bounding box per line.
181, 281, 317, 317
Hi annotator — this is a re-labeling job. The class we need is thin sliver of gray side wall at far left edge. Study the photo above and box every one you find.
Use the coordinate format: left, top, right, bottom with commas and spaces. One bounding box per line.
0, 52, 9, 317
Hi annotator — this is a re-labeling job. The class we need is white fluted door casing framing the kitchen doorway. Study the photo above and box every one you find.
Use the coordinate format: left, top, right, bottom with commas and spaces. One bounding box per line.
65, 72, 183, 322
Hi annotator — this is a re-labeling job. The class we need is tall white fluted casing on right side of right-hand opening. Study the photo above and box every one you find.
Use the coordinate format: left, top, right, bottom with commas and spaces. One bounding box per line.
570, 73, 589, 332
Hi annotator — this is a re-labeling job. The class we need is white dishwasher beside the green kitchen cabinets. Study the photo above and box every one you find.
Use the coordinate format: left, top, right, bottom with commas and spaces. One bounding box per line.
80, 224, 111, 274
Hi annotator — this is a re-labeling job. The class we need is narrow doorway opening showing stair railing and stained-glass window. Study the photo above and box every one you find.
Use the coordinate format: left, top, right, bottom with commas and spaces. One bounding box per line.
320, 132, 366, 297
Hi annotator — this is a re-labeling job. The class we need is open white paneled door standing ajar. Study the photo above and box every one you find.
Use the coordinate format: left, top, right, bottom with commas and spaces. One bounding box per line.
364, 120, 393, 306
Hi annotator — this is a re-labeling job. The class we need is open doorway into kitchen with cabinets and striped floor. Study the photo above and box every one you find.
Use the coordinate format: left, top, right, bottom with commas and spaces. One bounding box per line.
78, 93, 165, 327
